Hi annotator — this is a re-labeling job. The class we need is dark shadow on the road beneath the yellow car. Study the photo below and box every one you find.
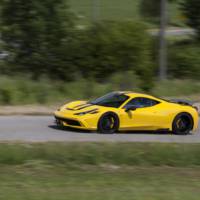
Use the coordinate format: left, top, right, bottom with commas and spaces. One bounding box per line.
48, 125, 186, 135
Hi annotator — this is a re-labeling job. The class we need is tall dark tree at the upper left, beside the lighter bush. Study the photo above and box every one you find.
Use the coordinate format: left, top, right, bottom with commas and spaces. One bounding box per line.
1, 0, 73, 78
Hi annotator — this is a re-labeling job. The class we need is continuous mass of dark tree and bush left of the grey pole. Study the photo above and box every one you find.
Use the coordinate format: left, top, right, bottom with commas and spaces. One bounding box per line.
0, 0, 154, 94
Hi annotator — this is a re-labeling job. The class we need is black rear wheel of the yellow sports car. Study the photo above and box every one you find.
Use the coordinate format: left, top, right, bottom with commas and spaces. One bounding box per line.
172, 113, 194, 135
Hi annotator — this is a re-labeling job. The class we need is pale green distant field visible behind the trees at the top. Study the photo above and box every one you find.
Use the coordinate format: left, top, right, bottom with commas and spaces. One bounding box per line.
69, 0, 183, 27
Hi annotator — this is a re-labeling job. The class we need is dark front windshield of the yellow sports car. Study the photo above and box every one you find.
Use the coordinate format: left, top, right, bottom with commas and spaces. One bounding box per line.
89, 93, 129, 108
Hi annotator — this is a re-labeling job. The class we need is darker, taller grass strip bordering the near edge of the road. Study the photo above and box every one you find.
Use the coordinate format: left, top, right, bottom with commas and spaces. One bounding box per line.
0, 143, 200, 169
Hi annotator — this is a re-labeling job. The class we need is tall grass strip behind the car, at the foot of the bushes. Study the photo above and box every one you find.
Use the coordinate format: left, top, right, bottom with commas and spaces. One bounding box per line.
0, 76, 200, 105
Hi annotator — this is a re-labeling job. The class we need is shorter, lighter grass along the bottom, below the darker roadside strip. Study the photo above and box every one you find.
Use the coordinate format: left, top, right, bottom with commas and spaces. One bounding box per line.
0, 166, 200, 200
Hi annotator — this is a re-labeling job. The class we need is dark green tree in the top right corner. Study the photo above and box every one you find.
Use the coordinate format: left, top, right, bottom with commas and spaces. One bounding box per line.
181, 0, 200, 40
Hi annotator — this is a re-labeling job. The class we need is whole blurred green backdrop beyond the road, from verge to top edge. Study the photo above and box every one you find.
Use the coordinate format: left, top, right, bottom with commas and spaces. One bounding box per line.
0, 0, 200, 105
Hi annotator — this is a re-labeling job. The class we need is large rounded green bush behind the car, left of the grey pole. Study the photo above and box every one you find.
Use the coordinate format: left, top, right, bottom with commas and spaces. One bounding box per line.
73, 22, 153, 89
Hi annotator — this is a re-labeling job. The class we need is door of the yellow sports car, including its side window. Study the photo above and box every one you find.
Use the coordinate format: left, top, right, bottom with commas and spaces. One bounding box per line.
120, 97, 161, 130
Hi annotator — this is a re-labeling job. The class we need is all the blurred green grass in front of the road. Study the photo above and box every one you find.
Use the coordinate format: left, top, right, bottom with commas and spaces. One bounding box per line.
0, 143, 200, 200
